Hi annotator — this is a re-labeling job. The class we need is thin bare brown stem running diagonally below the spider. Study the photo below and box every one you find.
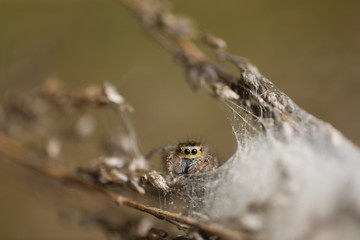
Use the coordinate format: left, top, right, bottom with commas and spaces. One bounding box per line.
0, 133, 258, 240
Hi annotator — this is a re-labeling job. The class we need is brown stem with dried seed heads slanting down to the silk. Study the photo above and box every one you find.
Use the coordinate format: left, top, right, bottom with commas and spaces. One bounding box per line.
117, 0, 298, 131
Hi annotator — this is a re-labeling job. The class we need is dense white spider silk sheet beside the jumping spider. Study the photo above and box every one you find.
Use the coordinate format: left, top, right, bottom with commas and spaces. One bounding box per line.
188, 104, 360, 240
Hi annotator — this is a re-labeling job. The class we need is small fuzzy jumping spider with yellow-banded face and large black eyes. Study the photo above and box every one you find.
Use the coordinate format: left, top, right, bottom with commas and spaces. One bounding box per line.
148, 140, 218, 178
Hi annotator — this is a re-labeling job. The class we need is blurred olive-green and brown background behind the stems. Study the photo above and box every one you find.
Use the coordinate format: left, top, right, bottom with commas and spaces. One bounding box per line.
0, 0, 360, 240
